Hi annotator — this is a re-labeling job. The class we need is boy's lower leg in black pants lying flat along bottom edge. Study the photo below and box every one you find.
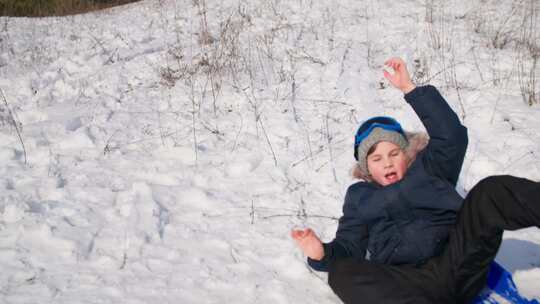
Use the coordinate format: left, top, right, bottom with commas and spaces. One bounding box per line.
328, 259, 444, 304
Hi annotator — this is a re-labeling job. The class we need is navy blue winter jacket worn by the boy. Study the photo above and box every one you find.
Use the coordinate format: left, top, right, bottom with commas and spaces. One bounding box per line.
308, 86, 468, 271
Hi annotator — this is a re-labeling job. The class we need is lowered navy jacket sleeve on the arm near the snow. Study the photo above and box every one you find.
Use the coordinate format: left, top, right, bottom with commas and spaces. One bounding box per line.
308, 187, 368, 271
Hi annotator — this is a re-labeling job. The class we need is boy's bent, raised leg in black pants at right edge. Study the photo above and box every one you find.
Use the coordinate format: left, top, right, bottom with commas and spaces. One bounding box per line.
437, 176, 540, 303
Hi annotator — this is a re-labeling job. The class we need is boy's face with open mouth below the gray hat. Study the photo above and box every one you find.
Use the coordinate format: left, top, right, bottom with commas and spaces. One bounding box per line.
367, 141, 409, 186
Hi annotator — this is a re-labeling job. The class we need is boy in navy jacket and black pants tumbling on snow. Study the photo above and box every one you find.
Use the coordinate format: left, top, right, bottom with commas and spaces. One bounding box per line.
291, 58, 540, 303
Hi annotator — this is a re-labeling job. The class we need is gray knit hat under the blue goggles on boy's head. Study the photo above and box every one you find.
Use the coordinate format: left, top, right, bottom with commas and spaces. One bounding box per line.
356, 127, 409, 175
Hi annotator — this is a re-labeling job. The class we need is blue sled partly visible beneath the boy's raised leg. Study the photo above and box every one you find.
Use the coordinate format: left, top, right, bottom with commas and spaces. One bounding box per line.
472, 262, 540, 304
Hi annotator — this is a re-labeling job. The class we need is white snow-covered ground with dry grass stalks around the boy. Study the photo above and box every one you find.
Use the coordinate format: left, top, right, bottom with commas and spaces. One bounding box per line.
0, 0, 540, 303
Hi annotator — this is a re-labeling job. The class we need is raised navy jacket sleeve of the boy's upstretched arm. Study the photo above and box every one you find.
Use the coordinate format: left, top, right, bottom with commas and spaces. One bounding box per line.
405, 85, 468, 186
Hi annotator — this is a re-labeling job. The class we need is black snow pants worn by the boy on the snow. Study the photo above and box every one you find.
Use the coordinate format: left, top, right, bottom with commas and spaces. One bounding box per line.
328, 176, 540, 304
